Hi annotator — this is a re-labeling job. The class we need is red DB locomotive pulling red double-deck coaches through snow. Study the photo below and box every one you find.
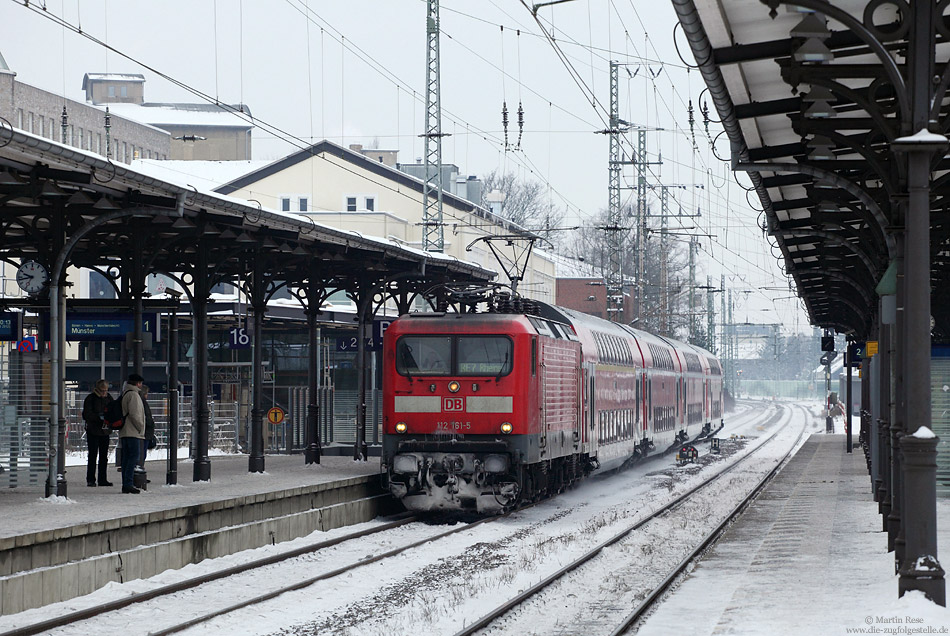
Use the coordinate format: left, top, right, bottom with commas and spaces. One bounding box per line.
382, 299, 723, 513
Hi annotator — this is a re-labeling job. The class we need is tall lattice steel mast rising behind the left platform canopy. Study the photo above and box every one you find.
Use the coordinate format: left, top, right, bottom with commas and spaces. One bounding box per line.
422, 0, 445, 252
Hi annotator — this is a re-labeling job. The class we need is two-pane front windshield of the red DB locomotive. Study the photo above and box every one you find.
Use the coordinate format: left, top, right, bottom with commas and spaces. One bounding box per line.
396, 336, 513, 377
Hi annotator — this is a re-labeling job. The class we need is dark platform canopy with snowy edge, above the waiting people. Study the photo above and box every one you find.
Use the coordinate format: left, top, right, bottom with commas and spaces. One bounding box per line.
0, 125, 495, 304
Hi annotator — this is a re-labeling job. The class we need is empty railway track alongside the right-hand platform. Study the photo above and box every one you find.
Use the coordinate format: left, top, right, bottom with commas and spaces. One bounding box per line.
455, 407, 805, 636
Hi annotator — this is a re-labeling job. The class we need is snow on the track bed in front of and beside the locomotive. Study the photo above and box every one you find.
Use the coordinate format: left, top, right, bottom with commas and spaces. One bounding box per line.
0, 402, 804, 635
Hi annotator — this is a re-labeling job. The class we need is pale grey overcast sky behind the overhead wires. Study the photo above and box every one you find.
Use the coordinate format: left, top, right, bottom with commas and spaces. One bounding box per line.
0, 0, 808, 330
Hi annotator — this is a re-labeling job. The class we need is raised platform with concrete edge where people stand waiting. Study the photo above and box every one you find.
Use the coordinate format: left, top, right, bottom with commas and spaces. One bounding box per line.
0, 455, 394, 615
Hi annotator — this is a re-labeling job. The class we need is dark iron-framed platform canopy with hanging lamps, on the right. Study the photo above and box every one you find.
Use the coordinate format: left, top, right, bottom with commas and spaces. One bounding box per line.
672, 0, 950, 339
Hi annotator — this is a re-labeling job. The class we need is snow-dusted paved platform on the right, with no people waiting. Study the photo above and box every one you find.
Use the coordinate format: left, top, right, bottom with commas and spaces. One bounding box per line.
637, 434, 950, 636
